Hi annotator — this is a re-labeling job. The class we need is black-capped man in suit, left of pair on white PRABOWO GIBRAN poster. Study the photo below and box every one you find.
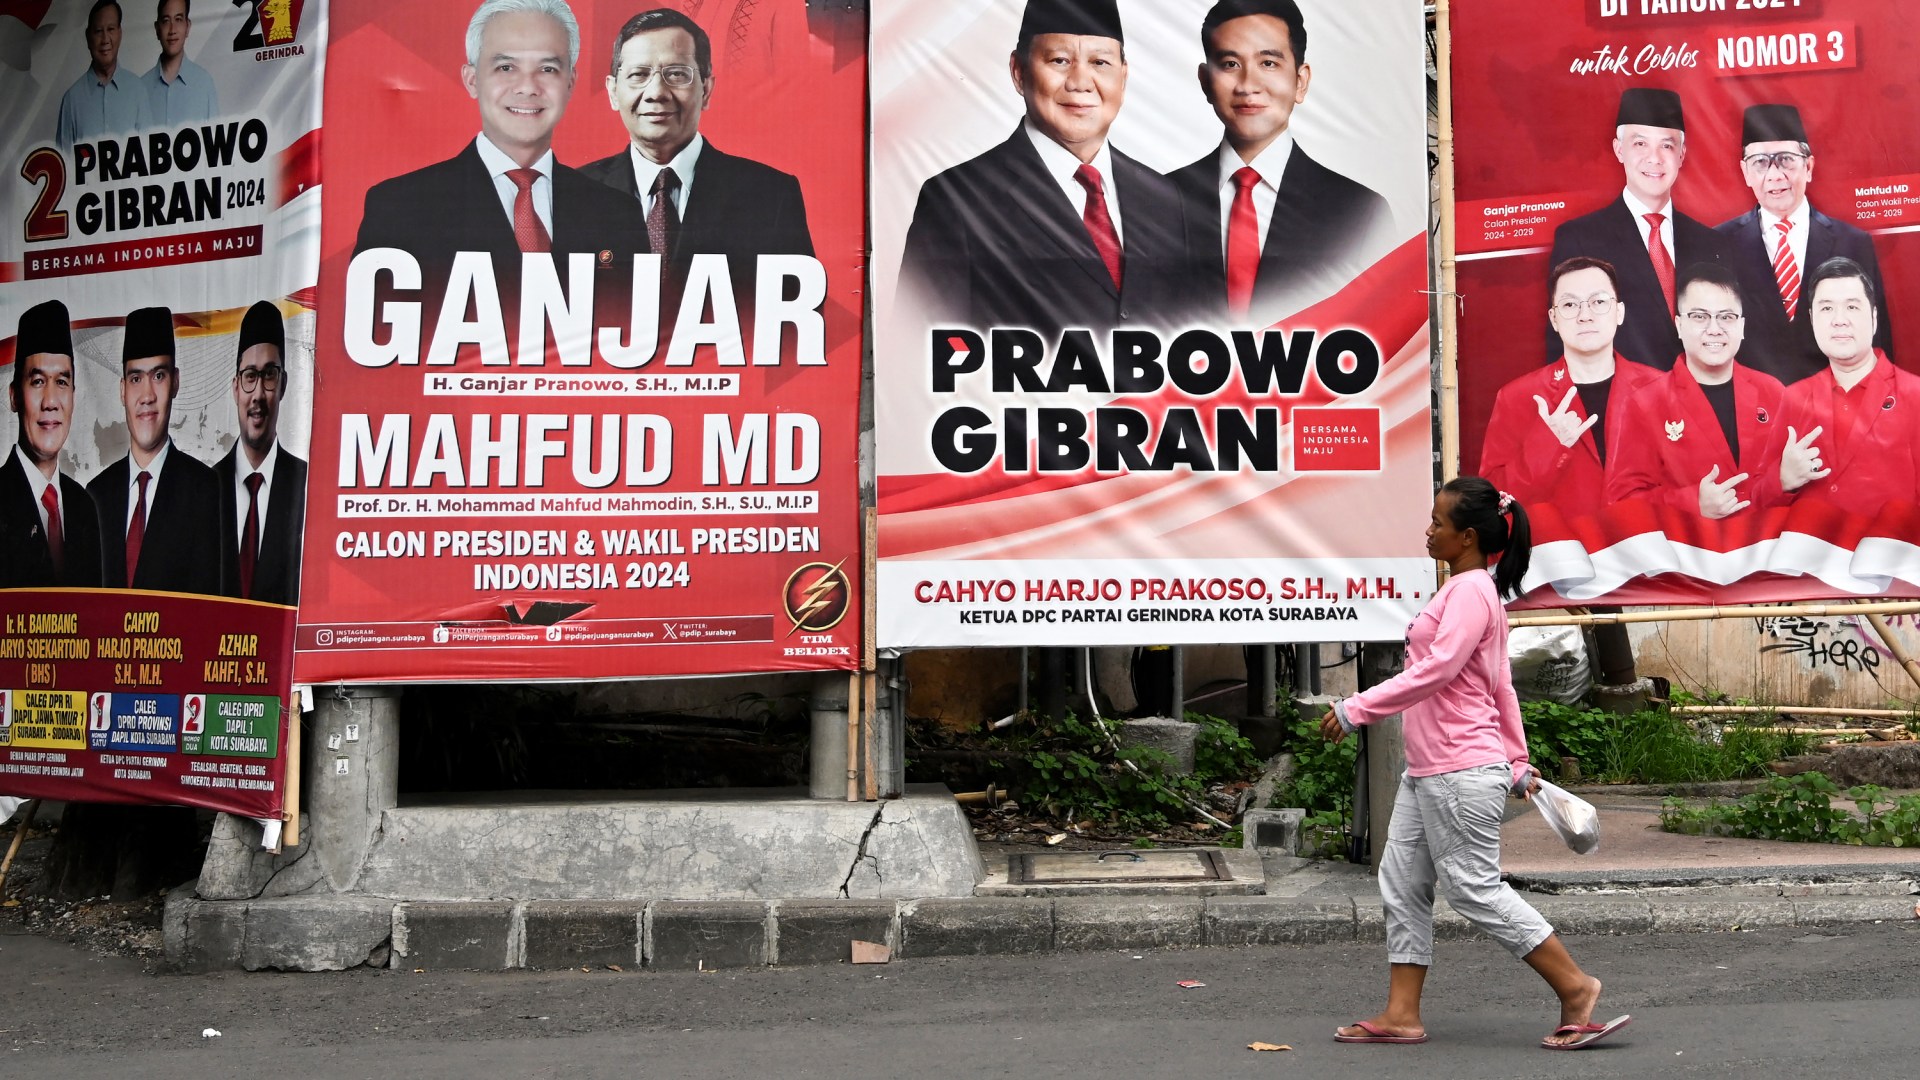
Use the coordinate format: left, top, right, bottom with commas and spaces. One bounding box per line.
900, 0, 1192, 334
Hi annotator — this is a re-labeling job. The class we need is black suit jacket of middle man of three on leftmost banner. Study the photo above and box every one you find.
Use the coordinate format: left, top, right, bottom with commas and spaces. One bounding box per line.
86, 444, 227, 596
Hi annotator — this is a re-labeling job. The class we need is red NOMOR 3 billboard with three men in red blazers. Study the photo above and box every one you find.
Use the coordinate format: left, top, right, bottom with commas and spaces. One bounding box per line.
1452, 0, 1920, 607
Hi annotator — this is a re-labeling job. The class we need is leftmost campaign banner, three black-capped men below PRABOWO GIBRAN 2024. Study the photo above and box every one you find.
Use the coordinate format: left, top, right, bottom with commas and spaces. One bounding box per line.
0, 0, 326, 819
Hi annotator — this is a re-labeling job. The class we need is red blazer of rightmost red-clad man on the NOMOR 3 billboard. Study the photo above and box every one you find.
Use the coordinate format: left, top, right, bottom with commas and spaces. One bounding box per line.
1780, 350, 1920, 513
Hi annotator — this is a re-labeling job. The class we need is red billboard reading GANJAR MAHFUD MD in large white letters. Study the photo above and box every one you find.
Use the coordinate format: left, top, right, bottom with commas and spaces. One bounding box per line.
298, 0, 866, 682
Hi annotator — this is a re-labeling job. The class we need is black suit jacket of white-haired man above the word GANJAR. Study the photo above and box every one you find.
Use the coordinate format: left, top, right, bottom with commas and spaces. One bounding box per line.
353, 142, 647, 263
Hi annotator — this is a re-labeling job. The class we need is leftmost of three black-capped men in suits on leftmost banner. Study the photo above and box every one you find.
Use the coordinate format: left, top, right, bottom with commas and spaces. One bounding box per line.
0, 300, 100, 588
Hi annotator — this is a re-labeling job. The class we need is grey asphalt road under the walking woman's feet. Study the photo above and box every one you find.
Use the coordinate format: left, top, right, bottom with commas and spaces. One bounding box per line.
0, 920, 1920, 1080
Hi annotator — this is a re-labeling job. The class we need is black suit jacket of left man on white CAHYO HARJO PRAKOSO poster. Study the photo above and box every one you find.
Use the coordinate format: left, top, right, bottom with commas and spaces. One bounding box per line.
900, 129, 1200, 336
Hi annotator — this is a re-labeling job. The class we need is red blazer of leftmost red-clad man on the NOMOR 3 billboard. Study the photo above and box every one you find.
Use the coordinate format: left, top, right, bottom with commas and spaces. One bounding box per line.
1480, 354, 1661, 517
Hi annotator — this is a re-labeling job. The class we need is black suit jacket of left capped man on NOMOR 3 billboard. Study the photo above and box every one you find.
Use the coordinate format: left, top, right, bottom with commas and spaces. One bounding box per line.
1540, 196, 1751, 371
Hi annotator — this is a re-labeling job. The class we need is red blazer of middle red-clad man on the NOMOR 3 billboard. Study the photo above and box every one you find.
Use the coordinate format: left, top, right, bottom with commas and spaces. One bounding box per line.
1607, 359, 1788, 515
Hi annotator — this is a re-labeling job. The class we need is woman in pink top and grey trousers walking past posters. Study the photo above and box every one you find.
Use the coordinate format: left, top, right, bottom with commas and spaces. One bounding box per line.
1321, 477, 1630, 1049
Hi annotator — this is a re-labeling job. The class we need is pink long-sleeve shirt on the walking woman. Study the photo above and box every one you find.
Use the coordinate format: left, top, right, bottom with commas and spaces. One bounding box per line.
1340, 571, 1526, 782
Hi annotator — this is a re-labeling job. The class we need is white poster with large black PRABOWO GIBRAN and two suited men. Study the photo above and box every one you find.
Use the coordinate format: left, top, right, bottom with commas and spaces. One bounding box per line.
872, 0, 1434, 648
